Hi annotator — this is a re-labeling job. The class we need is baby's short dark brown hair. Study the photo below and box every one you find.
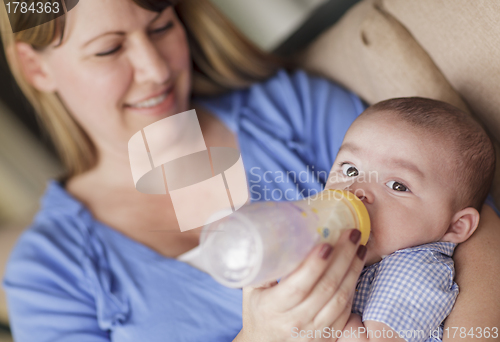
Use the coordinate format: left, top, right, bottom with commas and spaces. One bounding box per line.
363, 97, 495, 211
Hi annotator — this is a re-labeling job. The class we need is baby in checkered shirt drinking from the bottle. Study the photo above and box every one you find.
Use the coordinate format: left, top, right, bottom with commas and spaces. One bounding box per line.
326, 97, 495, 342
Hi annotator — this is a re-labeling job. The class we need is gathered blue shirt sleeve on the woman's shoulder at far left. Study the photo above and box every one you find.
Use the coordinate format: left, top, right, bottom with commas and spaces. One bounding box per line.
3, 182, 129, 341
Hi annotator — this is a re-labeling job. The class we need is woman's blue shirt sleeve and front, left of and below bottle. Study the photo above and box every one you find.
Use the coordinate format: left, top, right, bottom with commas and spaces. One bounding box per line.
4, 182, 242, 342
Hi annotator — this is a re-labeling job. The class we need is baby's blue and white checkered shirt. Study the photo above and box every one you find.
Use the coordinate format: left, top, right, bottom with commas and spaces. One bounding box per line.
352, 242, 458, 342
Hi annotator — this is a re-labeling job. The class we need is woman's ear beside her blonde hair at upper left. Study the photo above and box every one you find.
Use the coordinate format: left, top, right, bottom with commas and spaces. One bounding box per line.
15, 42, 56, 93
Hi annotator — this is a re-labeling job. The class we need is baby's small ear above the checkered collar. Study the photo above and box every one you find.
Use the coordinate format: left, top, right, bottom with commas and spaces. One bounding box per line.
439, 207, 479, 243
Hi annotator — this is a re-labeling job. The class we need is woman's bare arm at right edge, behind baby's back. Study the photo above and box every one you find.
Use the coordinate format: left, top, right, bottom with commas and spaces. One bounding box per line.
443, 205, 500, 342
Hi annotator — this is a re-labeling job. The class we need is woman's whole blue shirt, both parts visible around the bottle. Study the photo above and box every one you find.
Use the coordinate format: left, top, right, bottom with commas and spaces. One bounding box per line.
3, 71, 364, 342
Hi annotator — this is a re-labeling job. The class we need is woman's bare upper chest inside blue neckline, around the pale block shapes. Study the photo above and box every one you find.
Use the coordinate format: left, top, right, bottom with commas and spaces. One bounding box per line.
66, 110, 237, 257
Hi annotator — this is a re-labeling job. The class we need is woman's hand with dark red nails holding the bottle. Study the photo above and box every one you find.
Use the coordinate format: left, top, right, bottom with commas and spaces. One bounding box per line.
235, 230, 366, 342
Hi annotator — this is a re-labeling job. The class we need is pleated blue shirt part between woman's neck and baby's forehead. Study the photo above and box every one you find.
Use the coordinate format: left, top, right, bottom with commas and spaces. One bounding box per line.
197, 70, 366, 200
